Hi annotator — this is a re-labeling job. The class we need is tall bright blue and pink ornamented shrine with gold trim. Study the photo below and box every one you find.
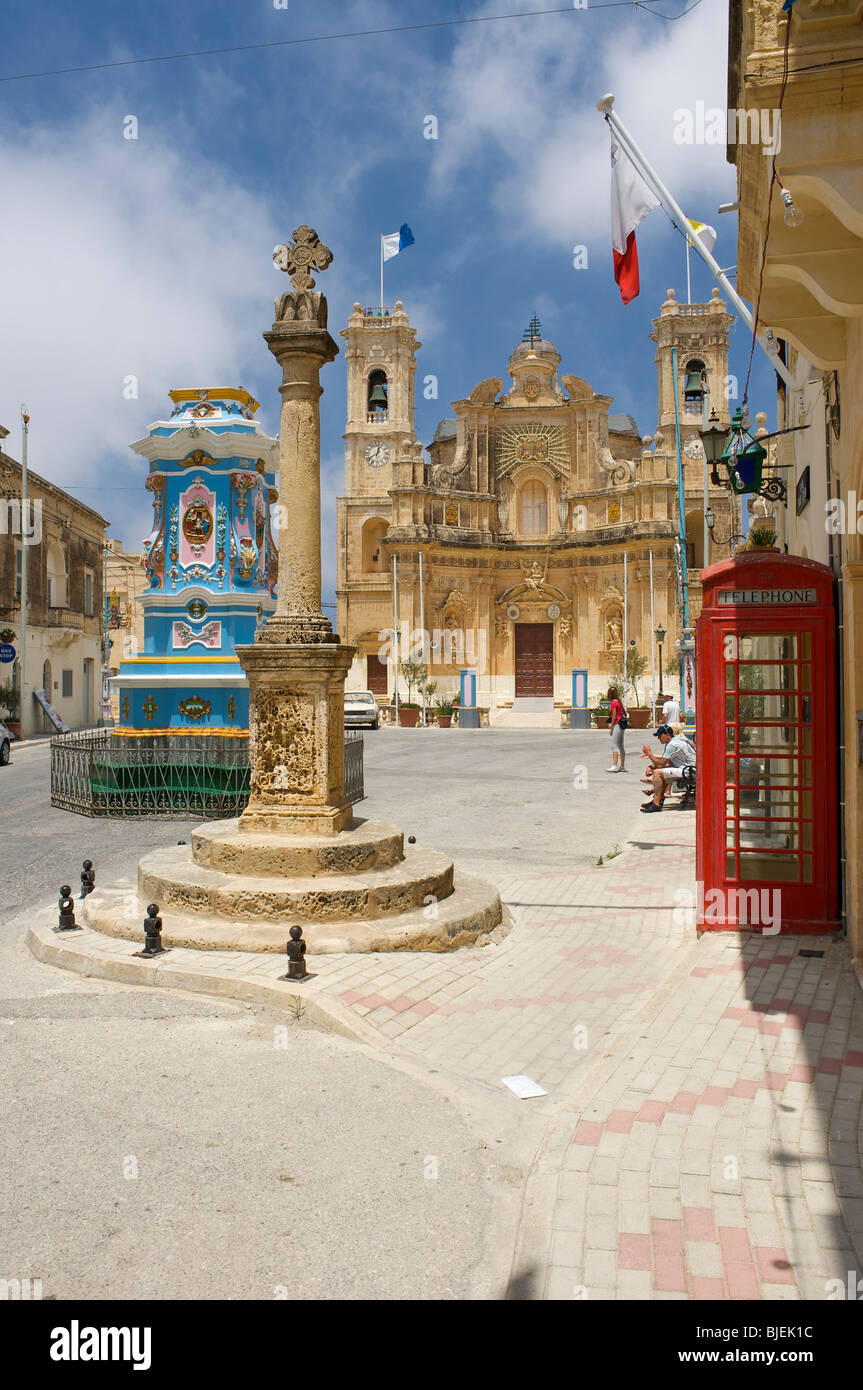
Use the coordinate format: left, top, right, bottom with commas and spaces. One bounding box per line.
114, 388, 278, 738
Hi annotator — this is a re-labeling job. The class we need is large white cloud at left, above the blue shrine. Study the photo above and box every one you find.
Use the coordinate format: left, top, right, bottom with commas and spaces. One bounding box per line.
0, 108, 281, 539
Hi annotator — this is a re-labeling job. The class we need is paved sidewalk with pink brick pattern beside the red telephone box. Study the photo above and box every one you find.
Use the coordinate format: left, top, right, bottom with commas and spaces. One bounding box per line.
23, 772, 863, 1300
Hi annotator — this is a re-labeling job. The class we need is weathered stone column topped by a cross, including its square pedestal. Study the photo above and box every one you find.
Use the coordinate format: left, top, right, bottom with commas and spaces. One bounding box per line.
236, 227, 354, 835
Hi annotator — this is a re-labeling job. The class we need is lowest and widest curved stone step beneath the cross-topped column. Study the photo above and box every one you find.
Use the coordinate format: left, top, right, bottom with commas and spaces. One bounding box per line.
81, 878, 513, 958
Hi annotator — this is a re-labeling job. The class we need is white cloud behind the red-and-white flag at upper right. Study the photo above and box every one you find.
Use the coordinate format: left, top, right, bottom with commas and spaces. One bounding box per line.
434, 0, 734, 243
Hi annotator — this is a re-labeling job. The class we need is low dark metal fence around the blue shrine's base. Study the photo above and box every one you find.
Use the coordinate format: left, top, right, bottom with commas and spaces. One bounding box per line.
51, 728, 365, 820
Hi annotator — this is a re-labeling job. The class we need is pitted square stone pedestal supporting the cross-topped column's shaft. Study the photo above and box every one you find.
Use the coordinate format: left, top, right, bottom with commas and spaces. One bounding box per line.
236, 636, 354, 835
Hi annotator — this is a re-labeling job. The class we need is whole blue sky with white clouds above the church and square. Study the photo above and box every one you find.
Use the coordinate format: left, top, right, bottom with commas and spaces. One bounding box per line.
0, 0, 775, 599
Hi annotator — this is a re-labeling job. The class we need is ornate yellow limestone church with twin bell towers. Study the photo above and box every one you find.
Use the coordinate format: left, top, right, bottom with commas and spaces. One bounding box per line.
338, 291, 739, 726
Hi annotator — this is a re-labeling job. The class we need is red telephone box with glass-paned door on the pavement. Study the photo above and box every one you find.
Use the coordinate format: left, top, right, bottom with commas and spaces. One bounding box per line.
695, 550, 839, 935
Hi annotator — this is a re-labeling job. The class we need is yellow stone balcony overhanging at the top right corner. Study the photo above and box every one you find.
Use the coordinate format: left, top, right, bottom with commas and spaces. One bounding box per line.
728, 0, 863, 370
